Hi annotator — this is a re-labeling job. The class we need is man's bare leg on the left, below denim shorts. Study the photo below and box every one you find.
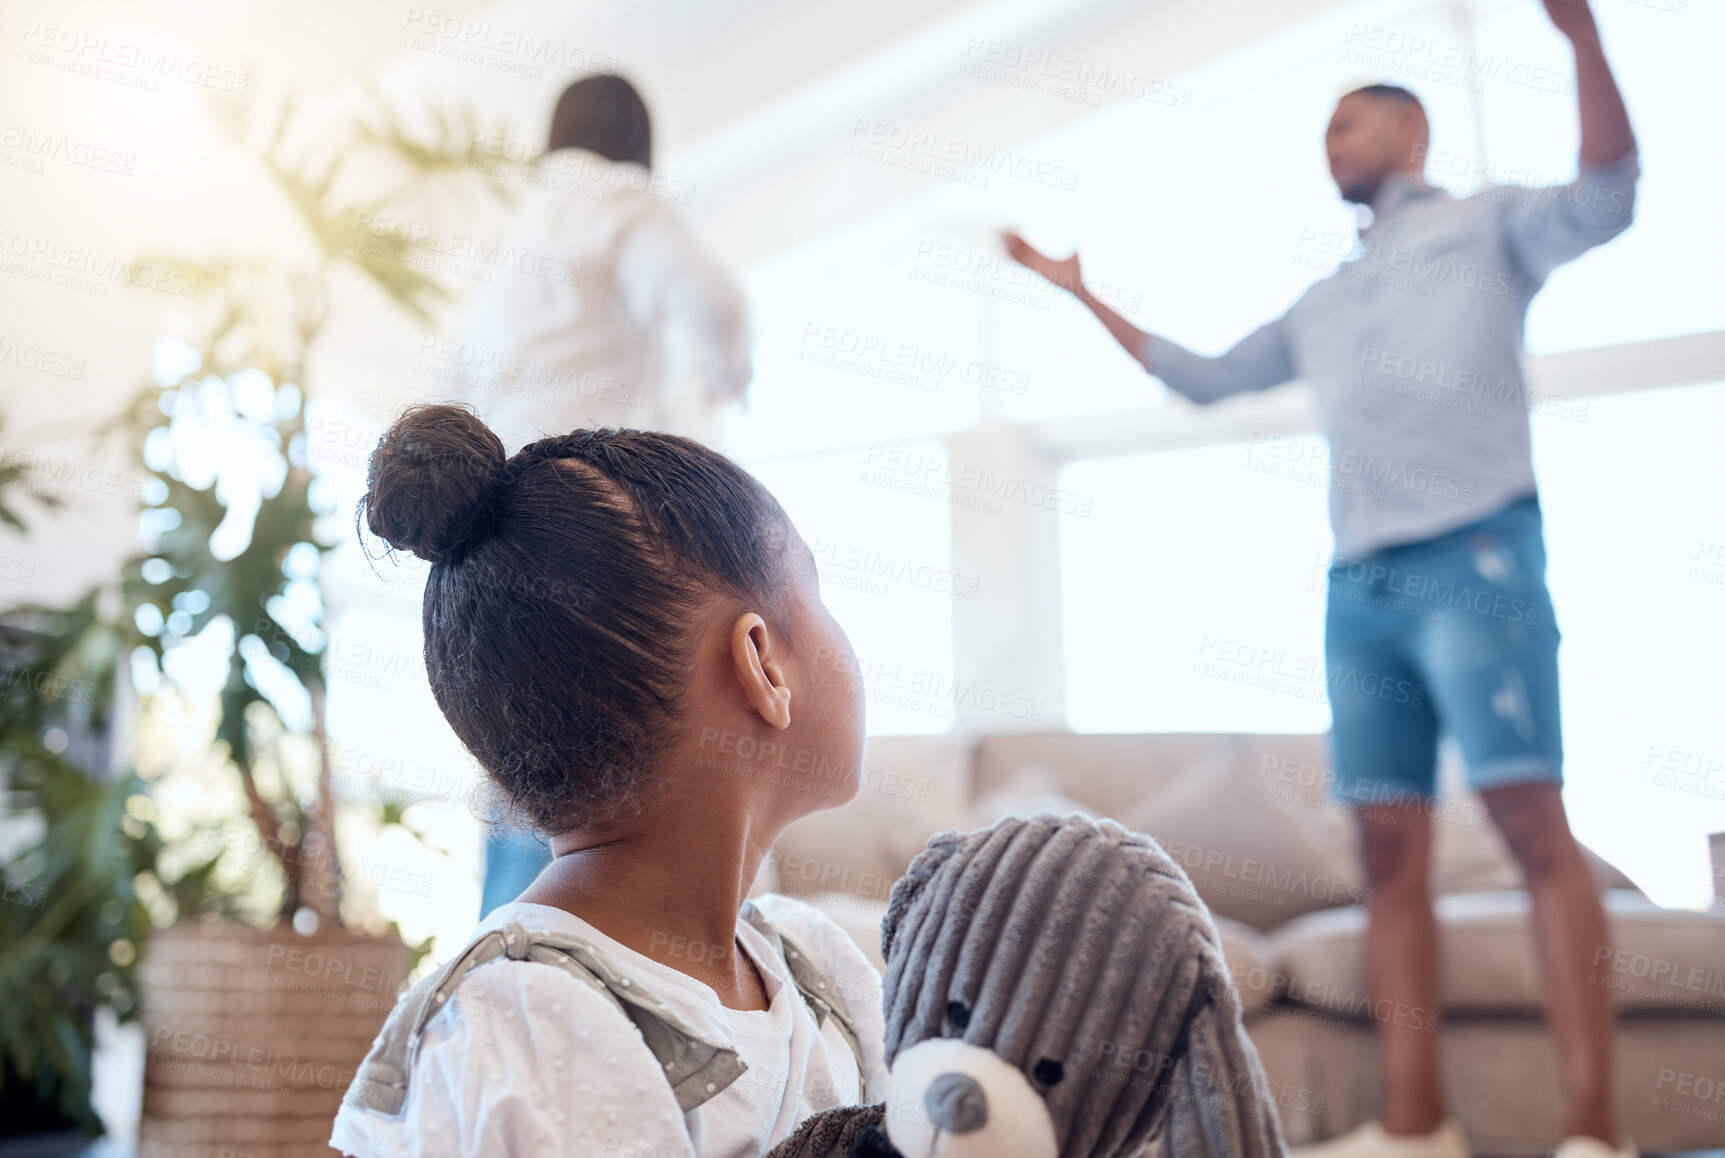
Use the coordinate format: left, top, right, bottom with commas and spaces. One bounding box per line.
1356, 804, 1444, 1134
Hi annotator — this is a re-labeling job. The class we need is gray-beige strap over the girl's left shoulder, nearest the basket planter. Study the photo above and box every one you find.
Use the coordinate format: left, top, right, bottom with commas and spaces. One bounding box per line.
347, 923, 749, 1117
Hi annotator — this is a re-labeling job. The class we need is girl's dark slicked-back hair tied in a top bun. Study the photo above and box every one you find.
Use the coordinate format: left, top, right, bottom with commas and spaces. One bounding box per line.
361, 406, 790, 834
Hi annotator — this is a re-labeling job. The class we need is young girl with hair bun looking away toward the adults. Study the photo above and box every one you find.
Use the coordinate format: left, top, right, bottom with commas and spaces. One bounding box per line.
331, 406, 887, 1158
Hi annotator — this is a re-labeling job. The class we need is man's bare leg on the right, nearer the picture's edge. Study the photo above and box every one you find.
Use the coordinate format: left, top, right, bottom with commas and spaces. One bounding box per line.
1480, 784, 1618, 1148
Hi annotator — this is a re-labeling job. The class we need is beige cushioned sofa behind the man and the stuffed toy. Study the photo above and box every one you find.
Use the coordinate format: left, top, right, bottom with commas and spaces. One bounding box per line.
773, 733, 1725, 1155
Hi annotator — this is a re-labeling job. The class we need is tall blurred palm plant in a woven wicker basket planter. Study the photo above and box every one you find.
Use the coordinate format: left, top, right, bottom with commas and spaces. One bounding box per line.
121, 99, 520, 1155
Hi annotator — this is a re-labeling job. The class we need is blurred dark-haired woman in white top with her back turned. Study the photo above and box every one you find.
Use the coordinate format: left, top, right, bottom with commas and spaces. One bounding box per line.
459, 74, 750, 913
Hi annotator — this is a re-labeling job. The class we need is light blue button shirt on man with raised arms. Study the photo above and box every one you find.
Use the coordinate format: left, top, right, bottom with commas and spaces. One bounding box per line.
1142, 150, 1640, 559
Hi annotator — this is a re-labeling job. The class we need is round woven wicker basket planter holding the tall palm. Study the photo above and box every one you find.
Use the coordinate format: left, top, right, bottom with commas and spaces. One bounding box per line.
138, 922, 407, 1158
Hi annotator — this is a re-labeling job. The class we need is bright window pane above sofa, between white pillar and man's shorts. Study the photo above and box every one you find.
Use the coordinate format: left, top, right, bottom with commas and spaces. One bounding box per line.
1061, 438, 1330, 732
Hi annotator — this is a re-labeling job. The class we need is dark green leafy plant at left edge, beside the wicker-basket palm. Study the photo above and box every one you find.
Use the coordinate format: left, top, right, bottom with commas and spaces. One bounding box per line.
0, 507, 160, 1153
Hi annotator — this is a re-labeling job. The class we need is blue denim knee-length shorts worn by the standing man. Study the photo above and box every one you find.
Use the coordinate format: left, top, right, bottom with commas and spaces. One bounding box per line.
1323, 499, 1563, 806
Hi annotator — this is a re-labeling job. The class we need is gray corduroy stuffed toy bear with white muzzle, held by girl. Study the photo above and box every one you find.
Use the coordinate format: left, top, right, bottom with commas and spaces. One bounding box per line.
768, 815, 1285, 1158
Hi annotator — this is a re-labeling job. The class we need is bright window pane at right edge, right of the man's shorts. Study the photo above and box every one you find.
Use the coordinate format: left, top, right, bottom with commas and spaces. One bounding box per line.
1534, 385, 1725, 904
